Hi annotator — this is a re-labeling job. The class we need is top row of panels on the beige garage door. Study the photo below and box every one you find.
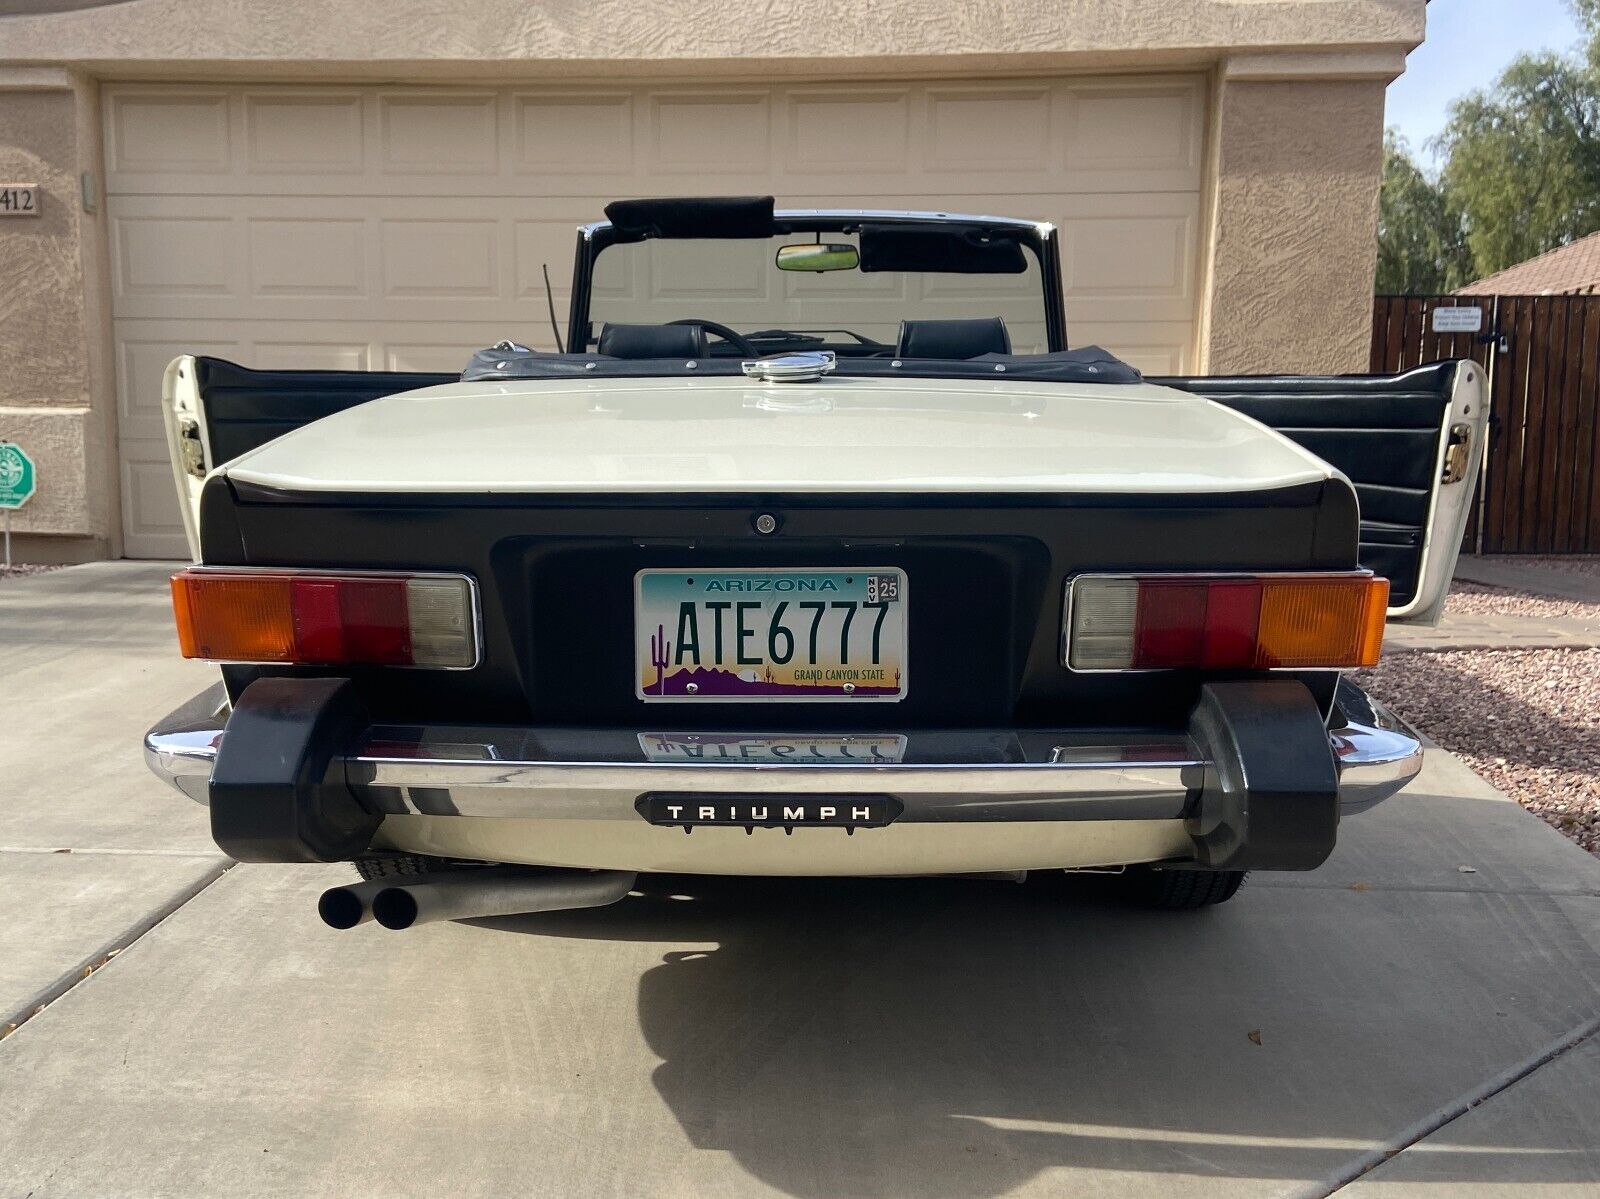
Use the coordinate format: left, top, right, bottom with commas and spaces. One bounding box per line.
106, 78, 1205, 197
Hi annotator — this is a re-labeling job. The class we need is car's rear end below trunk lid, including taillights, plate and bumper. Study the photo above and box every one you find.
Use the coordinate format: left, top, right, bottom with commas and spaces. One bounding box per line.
147, 471, 1421, 876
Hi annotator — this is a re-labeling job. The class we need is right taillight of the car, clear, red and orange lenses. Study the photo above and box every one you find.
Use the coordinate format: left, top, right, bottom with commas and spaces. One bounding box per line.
1066, 573, 1389, 671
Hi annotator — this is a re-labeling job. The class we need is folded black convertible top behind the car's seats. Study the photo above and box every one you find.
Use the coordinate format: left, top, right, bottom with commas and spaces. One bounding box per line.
461, 346, 1144, 383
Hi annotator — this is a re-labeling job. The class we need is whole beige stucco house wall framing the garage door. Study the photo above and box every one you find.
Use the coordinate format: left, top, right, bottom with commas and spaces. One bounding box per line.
0, 0, 1426, 557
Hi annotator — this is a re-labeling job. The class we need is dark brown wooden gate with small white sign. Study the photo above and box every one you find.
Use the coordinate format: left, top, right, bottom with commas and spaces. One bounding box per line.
1371, 296, 1600, 554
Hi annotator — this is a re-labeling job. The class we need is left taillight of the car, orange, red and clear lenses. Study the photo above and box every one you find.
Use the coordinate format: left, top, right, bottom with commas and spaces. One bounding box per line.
173, 568, 477, 669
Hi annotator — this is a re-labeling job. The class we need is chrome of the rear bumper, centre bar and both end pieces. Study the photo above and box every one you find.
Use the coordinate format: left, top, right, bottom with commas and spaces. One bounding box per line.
144, 685, 1422, 823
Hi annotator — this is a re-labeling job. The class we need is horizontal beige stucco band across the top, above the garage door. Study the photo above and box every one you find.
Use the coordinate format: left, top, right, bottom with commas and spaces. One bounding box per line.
0, 0, 1424, 78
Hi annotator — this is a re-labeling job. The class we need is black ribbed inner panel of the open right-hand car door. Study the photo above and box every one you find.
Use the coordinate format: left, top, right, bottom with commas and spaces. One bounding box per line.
1150, 362, 1459, 607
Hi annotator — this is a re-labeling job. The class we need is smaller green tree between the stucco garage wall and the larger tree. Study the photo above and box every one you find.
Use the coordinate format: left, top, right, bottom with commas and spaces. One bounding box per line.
1378, 130, 1472, 296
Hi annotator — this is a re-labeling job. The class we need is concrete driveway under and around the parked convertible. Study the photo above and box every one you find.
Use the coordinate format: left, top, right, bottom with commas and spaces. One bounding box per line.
0, 563, 1600, 1199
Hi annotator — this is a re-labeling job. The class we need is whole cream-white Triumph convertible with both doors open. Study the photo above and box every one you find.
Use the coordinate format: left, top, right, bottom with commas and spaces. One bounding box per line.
146, 197, 1486, 928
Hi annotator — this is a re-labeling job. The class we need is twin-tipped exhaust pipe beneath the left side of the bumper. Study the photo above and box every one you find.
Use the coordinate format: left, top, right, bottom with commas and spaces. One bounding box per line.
317, 866, 637, 930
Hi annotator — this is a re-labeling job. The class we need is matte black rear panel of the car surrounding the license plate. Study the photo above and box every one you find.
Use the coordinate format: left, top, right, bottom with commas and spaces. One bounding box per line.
202, 479, 1355, 732
